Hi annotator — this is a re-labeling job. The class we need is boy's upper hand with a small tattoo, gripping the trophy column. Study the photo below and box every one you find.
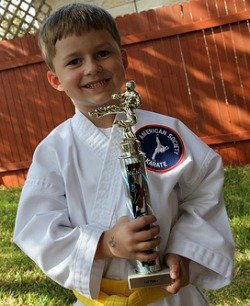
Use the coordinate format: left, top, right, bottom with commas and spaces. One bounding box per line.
95, 215, 160, 261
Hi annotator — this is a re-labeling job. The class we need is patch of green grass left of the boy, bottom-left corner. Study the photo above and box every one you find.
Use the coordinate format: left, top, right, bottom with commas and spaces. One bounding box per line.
0, 188, 75, 306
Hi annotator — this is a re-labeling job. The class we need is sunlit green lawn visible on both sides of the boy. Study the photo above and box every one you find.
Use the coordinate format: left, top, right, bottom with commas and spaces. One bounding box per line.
0, 167, 250, 306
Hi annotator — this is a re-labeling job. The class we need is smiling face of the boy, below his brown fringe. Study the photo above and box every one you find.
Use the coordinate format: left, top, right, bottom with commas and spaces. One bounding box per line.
47, 30, 127, 124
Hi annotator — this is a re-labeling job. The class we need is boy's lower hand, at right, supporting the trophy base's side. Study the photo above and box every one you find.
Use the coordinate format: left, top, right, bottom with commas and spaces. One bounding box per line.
165, 254, 190, 293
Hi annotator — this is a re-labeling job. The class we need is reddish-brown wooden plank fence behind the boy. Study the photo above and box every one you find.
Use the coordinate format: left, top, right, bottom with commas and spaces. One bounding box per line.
0, 0, 250, 186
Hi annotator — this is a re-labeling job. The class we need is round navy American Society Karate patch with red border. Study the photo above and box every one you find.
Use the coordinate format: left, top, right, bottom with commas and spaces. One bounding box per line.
136, 125, 184, 172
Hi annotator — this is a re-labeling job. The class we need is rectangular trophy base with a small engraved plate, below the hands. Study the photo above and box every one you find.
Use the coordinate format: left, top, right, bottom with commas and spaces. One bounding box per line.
128, 268, 171, 289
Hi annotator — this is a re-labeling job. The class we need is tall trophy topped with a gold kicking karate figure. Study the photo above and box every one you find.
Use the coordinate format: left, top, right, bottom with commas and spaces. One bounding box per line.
89, 80, 171, 289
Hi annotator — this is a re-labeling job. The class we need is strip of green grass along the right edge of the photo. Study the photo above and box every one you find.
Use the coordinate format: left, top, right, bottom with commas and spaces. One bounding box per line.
205, 166, 250, 306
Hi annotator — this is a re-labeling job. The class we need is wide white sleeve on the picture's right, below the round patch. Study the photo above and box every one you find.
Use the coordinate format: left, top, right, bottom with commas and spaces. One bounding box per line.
166, 150, 234, 289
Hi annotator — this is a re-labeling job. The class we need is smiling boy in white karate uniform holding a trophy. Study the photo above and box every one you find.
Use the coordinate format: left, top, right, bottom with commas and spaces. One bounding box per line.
14, 3, 234, 306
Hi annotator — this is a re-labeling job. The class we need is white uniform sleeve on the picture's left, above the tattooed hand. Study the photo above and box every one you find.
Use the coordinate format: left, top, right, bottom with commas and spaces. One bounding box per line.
14, 143, 104, 297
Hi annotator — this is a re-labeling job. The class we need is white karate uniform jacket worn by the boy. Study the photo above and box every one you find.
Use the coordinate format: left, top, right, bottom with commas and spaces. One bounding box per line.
14, 110, 234, 306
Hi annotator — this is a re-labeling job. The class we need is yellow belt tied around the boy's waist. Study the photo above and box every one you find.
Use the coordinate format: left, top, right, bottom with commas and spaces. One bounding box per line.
73, 278, 169, 306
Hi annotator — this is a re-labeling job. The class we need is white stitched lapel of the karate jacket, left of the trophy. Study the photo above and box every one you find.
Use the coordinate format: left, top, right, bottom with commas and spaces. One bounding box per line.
73, 111, 126, 228
